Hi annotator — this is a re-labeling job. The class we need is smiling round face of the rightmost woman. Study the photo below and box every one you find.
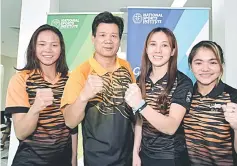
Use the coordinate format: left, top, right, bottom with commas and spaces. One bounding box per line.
191, 47, 222, 86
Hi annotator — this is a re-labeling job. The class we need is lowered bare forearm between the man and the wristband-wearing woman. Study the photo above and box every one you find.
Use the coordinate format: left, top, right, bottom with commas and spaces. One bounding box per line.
133, 119, 142, 153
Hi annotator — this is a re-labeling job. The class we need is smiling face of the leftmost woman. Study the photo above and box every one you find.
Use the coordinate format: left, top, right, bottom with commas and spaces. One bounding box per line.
36, 30, 61, 67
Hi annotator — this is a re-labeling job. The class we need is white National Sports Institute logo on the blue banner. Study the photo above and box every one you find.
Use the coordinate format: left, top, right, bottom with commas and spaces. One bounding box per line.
132, 13, 163, 24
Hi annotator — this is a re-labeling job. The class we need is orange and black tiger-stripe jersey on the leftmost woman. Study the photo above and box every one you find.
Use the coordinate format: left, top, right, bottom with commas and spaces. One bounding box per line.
5, 70, 72, 166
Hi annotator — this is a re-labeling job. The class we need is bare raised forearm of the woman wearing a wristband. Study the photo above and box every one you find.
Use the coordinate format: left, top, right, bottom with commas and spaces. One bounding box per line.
141, 105, 179, 135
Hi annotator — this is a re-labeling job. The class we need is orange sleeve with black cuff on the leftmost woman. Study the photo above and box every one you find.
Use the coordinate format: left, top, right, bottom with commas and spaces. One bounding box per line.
5, 72, 30, 117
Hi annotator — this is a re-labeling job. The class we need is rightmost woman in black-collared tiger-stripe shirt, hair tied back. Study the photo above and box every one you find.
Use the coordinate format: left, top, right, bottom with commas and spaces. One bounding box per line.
184, 41, 237, 166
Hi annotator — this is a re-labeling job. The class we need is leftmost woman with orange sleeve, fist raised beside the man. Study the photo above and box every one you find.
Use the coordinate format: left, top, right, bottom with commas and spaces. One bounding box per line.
5, 24, 77, 166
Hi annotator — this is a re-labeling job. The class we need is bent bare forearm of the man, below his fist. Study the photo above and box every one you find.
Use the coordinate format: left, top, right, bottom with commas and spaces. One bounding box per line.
63, 96, 88, 129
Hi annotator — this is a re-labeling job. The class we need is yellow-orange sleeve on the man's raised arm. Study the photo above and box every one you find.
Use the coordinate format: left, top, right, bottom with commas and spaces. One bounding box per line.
61, 68, 86, 111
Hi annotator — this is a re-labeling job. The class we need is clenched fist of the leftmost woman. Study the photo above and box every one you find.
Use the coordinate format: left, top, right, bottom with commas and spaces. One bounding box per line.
32, 88, 54, 113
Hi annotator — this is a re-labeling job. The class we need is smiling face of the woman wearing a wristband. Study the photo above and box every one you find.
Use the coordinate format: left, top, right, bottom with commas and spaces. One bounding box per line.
146, 32, 173, 67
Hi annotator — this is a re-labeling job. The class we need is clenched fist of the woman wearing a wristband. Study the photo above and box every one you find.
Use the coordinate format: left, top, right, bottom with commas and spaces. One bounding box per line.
124, 83, 142, 109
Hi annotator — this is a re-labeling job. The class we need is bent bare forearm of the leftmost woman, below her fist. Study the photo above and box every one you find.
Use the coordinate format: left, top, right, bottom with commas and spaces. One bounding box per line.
13, 107, 39, 140
